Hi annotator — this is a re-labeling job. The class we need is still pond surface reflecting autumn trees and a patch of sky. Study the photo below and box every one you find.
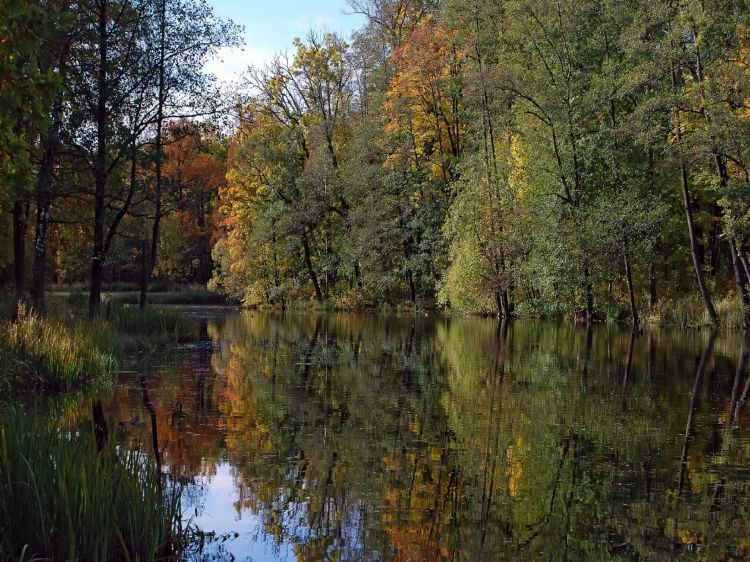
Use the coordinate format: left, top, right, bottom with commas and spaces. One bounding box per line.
86, 311, 750, 561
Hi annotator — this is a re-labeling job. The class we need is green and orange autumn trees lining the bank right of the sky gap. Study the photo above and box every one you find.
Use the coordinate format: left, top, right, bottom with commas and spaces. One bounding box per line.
212, 0, 750, 326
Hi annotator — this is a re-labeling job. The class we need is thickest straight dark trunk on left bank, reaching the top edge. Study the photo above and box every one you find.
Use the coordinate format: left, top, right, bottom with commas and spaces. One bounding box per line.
89, 0, 109, 317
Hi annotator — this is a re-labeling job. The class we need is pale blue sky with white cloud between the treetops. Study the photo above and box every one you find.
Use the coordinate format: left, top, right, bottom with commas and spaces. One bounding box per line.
206, 0, 364, 81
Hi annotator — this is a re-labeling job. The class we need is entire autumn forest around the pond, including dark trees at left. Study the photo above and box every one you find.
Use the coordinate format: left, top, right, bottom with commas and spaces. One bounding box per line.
0, 0, 750, 328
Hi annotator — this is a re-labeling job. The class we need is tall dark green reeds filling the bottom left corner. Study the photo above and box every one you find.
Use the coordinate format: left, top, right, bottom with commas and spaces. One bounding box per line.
0, 406, 188, 562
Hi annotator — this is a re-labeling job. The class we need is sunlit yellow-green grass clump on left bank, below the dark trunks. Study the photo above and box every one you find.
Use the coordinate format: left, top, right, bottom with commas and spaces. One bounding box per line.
0, 310, 114, 390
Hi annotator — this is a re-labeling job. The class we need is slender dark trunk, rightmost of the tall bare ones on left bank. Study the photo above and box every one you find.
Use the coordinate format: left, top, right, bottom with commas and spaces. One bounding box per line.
139, 0, 167, 310
